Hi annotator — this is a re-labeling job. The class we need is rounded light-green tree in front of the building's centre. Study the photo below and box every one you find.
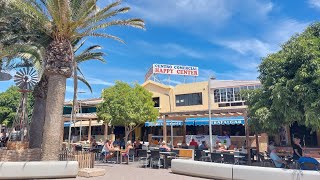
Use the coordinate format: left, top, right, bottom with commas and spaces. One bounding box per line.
97, 81, 159, 140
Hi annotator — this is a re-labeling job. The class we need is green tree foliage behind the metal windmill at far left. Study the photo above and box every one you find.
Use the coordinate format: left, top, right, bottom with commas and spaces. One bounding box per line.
0, 86, 34, 126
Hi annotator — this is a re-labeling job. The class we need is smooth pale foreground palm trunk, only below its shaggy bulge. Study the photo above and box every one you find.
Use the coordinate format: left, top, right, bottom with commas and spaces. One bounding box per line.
42, 74, 66, 161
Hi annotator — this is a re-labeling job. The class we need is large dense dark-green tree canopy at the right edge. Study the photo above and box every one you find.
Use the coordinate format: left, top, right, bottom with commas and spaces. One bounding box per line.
247, 23, 320, 132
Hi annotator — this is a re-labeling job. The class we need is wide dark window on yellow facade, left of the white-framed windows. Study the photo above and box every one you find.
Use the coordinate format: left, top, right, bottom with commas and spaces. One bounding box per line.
176, 93, 202, 106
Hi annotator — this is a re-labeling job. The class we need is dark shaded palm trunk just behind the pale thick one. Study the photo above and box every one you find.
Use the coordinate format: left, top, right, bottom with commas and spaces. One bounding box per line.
29, 75, 48, 148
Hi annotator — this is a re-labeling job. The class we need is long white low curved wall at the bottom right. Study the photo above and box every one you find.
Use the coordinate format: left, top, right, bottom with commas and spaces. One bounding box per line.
171, 159, 320, 180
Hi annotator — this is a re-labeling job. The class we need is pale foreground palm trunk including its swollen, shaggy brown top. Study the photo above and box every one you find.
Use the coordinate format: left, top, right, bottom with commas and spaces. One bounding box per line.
42, 37, 74, 161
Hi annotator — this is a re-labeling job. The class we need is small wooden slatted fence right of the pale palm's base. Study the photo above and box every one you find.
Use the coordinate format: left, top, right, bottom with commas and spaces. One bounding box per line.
59, 150, 95, 169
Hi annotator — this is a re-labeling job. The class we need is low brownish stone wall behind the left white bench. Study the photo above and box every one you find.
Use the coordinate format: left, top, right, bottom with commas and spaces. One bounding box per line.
0, 149, 41, 162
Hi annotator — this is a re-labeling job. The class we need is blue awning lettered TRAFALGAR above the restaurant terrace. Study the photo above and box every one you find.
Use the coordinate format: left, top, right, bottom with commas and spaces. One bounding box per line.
187, 116, 244, 126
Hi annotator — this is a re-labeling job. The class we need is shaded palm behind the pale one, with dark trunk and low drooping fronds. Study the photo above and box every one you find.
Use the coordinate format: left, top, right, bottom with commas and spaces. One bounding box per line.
0, 41, 105, 148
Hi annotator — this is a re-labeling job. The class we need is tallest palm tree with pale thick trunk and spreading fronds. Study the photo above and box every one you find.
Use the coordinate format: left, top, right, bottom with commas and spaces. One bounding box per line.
9, 0, 144, 160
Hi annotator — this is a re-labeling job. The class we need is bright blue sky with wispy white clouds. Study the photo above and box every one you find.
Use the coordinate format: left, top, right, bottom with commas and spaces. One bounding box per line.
0, 0, 320, 100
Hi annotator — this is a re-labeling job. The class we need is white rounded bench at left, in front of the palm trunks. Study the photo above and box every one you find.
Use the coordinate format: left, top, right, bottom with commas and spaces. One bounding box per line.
0, 161, 78, 179
